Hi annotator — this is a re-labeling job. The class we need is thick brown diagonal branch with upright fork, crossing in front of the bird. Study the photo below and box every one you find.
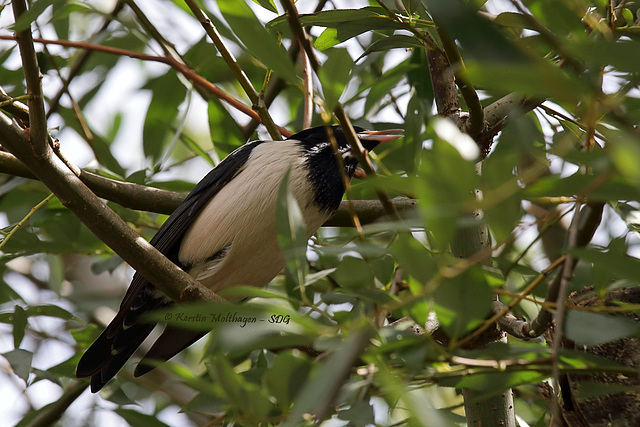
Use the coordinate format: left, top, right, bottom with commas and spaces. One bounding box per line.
0, 0, 220, 308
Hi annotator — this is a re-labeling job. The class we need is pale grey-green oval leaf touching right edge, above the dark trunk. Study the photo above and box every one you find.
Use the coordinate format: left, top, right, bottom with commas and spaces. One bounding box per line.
564, 310, 640, 347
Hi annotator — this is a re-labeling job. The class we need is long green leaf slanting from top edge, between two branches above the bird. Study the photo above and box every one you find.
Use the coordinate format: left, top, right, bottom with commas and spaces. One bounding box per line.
217, 0, 300, 85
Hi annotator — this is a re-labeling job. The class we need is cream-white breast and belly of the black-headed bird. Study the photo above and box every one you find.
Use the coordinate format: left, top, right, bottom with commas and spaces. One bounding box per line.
179, 141, 328, 291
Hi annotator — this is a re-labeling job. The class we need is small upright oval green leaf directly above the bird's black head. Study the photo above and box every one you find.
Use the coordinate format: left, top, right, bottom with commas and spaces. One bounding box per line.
318, 49, 353, 111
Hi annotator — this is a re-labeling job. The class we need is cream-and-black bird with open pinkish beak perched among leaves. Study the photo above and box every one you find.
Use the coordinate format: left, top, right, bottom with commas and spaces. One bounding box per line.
76, 126, 402, 393
